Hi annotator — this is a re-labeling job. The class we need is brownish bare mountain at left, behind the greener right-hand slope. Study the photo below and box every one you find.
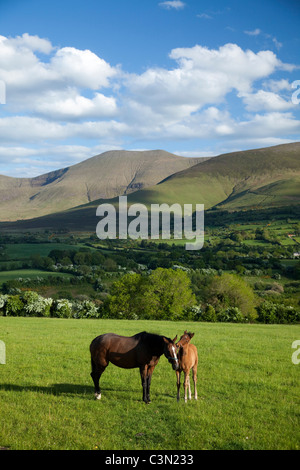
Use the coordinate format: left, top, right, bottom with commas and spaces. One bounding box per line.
0, 150, 205, 221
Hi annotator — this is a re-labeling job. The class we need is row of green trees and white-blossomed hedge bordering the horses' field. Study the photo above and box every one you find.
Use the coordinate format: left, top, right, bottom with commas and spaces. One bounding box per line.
0, 268, 300, 323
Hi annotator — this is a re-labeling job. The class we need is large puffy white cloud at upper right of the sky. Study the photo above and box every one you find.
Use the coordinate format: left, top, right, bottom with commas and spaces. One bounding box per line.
127, 44, 288, 120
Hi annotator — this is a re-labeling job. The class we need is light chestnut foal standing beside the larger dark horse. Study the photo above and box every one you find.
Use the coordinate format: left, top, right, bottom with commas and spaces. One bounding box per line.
176, 330, 198, 402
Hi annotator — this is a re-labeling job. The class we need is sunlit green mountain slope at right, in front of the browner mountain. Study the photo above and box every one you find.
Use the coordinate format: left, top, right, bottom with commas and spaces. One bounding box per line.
129, 142, 300, 209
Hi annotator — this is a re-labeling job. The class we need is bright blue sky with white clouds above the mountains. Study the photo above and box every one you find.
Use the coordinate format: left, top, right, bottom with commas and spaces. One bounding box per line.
0, 0, 300, 177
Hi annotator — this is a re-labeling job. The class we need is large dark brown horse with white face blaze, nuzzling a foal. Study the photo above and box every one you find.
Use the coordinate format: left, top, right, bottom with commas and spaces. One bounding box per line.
90, 331, 178, 403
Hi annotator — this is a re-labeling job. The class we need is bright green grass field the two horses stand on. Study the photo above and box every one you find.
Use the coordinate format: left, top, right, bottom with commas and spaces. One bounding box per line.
0, 317, 300, 450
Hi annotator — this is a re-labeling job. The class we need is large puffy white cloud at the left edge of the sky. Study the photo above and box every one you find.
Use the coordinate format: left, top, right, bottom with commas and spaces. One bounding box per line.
0, 34, 120, 120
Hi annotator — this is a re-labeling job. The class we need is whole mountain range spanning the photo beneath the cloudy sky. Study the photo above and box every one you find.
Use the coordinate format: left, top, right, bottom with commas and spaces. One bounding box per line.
0, 142, 300, 231
